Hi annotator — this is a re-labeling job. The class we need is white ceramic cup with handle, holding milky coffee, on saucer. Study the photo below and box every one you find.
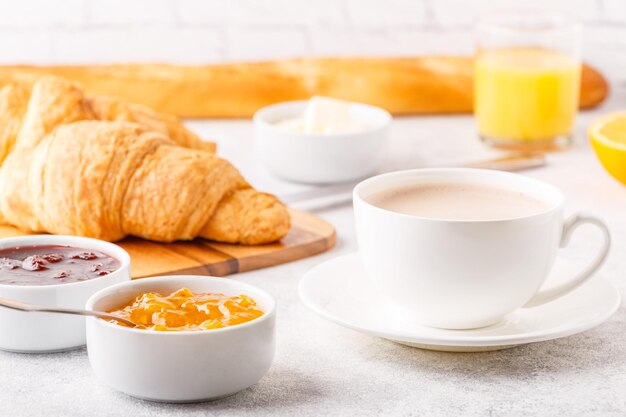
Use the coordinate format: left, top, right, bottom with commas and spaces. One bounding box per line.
353, 168, 611, 329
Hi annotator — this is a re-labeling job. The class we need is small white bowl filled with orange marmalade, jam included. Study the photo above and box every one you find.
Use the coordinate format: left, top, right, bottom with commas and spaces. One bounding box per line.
87, 276, 276, 402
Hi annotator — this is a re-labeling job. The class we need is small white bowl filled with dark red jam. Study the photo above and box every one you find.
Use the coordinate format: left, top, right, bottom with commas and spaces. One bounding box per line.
0, 235, 130, 352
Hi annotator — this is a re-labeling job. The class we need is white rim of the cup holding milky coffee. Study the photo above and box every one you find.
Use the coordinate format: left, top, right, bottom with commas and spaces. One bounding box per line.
352, 168, 565, 223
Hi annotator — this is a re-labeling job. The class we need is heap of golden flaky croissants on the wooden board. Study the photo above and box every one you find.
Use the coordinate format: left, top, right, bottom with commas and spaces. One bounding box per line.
0, 77, 290, 244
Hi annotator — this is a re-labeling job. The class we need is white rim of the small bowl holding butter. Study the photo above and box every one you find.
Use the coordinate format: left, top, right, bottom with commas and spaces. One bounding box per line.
252, 100, 392, 139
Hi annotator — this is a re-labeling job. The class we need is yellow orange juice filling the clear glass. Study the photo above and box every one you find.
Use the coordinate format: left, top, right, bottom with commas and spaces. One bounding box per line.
474, 48, 581, 141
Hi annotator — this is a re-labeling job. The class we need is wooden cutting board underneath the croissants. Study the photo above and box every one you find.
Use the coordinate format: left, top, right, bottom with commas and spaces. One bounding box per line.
0, 210, 335, 278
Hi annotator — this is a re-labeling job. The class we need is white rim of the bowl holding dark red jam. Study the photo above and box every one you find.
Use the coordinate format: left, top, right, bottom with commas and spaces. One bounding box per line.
0, 235, 130, 291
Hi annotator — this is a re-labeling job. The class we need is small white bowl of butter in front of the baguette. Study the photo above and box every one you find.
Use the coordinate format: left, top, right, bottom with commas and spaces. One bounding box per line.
254, 97, 391, 184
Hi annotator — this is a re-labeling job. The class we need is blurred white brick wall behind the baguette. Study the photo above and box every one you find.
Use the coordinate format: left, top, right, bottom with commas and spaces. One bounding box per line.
0, 0, 626, 80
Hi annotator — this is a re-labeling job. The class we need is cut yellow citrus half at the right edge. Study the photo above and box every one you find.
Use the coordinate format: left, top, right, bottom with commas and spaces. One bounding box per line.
589, 111, 626, 185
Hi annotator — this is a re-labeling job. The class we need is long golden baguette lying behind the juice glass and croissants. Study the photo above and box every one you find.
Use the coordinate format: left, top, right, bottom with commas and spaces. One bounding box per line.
0, 56, 608, 118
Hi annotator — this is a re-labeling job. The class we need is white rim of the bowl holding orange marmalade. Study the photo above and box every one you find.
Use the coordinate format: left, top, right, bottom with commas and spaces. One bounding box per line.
85, 275, 276, 337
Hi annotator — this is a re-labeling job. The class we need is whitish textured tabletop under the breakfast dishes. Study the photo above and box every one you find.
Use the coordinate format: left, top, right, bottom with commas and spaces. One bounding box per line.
0, 92, 626, 417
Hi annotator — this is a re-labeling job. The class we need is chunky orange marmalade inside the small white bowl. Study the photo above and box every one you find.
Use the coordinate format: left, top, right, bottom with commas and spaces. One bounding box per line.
110, 288, 263, 331
